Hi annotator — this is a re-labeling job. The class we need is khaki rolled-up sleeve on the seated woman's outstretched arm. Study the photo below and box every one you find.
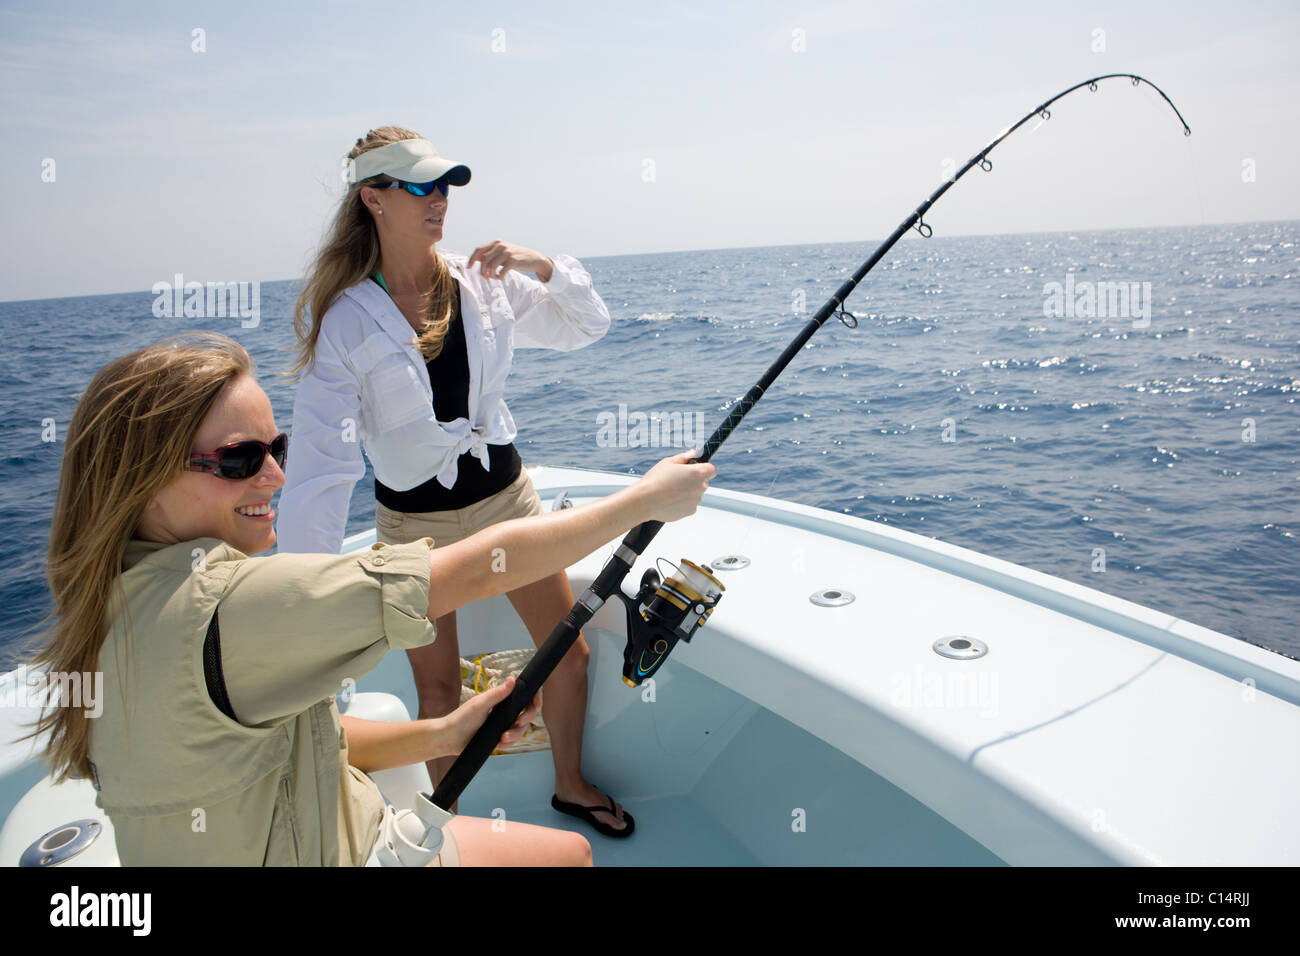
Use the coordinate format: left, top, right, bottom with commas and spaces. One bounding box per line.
218, 537, 436, 726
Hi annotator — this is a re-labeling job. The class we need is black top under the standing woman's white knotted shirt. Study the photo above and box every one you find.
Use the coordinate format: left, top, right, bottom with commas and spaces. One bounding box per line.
374, 274, 524, 514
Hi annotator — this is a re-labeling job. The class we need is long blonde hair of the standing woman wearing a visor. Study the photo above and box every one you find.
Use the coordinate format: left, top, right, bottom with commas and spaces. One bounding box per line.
290, 126, 456, 375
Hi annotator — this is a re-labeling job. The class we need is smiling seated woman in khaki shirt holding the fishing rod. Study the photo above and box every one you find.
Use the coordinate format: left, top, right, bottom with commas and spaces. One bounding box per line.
22, 336, 716, 865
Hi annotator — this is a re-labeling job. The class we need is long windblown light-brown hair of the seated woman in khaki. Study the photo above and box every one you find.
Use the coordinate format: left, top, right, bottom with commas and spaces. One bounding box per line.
22, 333, 252, 783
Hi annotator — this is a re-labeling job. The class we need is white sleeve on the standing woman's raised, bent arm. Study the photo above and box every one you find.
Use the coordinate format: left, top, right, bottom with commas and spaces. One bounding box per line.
506, 255, 610, 351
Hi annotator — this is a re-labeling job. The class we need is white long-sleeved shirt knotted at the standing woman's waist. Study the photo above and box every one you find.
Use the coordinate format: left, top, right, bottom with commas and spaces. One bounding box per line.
276, 252, 610, 554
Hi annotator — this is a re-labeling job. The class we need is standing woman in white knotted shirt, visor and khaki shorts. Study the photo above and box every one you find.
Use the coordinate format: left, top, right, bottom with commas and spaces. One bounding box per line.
277, 126, 633, 836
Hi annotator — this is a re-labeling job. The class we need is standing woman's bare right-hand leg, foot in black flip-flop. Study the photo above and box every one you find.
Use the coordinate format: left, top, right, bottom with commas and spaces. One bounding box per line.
506, 571, 627, 830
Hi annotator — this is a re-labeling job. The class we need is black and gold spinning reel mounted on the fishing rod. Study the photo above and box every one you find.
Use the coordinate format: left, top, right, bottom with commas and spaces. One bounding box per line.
614, 558, 727, 687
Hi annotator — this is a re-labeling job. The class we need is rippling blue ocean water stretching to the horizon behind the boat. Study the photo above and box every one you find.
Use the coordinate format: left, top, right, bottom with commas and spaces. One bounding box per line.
0, 221, 1300, 669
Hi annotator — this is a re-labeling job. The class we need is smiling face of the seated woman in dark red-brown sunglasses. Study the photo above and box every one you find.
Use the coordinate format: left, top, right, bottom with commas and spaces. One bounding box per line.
135, 371, 284, 554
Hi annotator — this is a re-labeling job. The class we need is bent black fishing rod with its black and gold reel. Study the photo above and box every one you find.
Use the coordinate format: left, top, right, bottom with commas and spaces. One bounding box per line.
426, 73, 1192, 810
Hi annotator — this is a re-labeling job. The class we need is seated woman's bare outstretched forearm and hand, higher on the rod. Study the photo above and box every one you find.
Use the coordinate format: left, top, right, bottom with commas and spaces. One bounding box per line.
429, 451, 718, 620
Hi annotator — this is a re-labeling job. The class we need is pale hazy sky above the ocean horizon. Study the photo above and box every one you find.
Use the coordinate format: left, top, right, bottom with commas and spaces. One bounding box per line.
0, 0, 1300, 299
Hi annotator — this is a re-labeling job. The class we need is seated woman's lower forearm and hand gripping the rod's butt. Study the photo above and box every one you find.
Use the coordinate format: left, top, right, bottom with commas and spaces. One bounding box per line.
338, 678, 542, 774
